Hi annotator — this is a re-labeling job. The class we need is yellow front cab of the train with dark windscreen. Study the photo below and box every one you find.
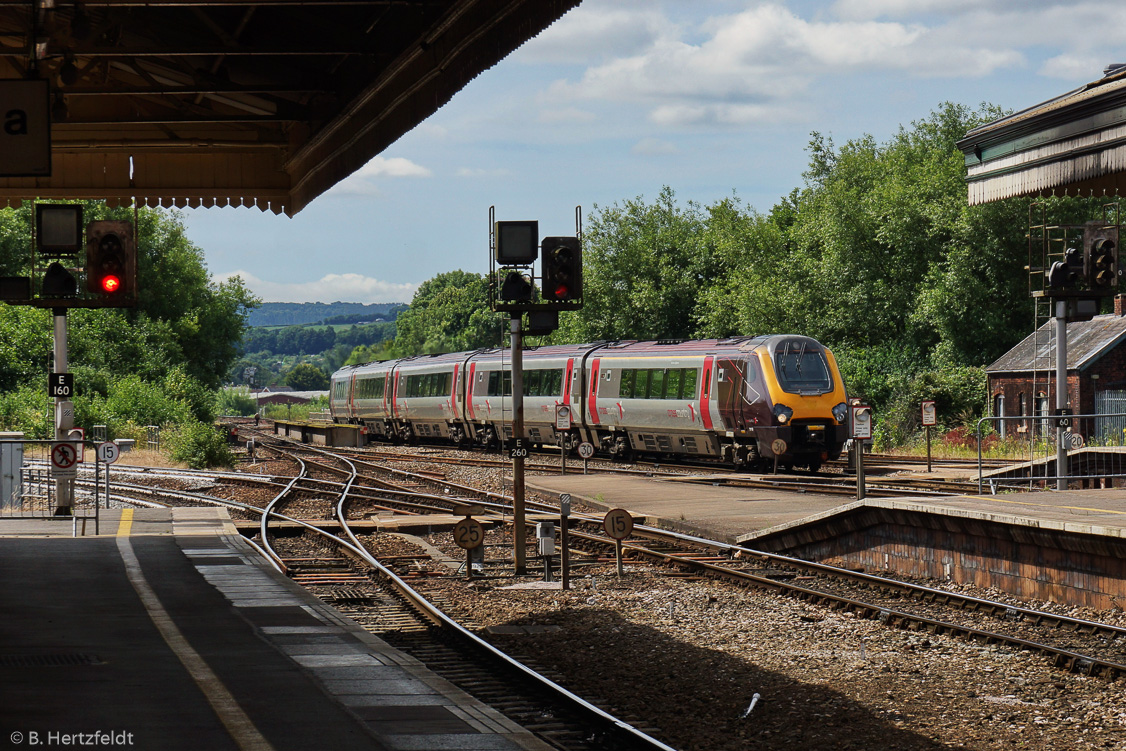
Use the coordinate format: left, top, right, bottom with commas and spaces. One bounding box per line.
744, 337, 848, 472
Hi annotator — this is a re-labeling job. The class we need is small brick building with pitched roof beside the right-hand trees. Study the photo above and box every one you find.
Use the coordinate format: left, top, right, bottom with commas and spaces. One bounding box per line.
985, 295, 1126, 442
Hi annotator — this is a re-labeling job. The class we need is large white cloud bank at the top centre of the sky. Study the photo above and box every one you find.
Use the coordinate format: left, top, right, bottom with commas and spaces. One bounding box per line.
546, 0, 1040, 126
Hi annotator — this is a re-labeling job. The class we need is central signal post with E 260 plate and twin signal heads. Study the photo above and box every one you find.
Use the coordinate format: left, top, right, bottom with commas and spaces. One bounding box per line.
489, 207, 582, 575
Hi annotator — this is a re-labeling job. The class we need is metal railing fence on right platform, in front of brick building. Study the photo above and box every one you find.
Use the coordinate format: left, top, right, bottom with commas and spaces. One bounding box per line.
976, 412, 1126, 493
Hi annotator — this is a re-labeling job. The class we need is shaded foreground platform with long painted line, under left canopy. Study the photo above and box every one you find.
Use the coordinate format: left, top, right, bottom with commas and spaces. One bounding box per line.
0, 509, 548, 751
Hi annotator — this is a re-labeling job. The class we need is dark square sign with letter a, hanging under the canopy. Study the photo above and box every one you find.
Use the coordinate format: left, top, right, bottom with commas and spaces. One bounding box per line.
0, 79, 51, 177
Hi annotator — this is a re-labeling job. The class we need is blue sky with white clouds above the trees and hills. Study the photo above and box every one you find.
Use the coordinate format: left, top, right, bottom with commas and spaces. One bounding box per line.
182, 0, 1126, 303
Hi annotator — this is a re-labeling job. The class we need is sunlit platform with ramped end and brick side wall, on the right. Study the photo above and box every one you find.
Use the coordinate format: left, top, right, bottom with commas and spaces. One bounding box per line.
526, 475, 1126, 610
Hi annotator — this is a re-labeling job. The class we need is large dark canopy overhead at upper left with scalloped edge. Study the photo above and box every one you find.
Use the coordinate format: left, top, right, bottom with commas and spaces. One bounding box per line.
0, 0, 581, 215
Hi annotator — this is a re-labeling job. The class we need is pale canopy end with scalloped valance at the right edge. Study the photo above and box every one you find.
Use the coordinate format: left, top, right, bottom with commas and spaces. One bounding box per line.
958, 65, 1126, 205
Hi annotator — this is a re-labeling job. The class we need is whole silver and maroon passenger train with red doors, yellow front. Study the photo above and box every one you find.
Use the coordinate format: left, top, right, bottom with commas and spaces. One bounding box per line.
330, 334, 848, 471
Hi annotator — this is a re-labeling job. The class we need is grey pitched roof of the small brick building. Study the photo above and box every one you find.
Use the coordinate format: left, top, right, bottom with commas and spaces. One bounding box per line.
985, 314, 1126, 374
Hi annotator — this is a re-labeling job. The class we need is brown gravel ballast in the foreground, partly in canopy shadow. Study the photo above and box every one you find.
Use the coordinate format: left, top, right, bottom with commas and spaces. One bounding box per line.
224, 441, 1126, 751
